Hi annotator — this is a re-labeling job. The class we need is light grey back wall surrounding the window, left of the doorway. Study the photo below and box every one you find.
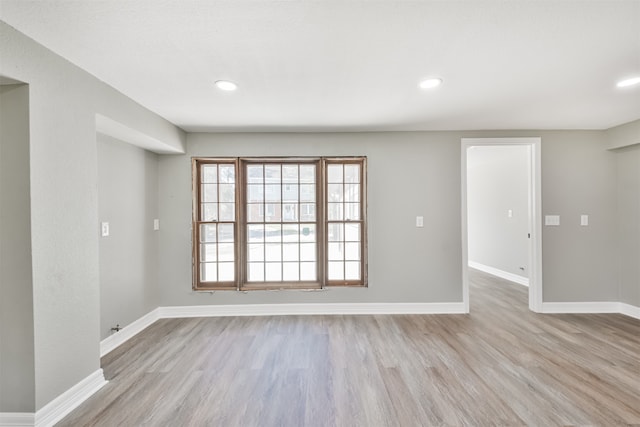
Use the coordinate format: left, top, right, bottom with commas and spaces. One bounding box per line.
159, 132, 462, 306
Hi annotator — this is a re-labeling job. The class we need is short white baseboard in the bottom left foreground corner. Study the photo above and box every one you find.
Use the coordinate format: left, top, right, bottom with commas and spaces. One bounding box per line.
35, 369, 107, 427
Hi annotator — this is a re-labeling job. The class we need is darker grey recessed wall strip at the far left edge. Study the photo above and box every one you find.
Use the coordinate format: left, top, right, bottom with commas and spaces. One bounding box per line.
0, 85, 35, 412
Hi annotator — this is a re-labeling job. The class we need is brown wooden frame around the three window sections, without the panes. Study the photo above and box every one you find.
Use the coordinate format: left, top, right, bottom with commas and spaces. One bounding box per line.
191, 156, 368, 291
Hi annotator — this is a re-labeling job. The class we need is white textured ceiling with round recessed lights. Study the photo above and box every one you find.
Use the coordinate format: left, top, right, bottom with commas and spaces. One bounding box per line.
0, 0, 640, 131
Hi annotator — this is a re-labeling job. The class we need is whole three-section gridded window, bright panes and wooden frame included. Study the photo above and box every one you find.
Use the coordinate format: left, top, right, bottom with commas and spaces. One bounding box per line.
193, 157, 366, 290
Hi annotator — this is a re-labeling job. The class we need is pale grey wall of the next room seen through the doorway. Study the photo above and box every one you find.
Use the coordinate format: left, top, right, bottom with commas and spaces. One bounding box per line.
467, 146, 529, 278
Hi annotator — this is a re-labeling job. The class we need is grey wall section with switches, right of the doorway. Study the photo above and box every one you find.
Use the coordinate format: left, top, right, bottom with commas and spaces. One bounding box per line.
541, 131, 618, 302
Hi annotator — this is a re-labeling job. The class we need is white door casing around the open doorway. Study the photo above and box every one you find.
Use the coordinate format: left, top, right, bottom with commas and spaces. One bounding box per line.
460, 137, 543, 313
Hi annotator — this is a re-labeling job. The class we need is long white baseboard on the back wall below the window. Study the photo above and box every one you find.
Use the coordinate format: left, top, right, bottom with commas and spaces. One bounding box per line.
160, 302, 465, 319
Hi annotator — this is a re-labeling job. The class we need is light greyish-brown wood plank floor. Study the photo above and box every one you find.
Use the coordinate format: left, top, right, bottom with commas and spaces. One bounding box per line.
58, 270, 640, 427
